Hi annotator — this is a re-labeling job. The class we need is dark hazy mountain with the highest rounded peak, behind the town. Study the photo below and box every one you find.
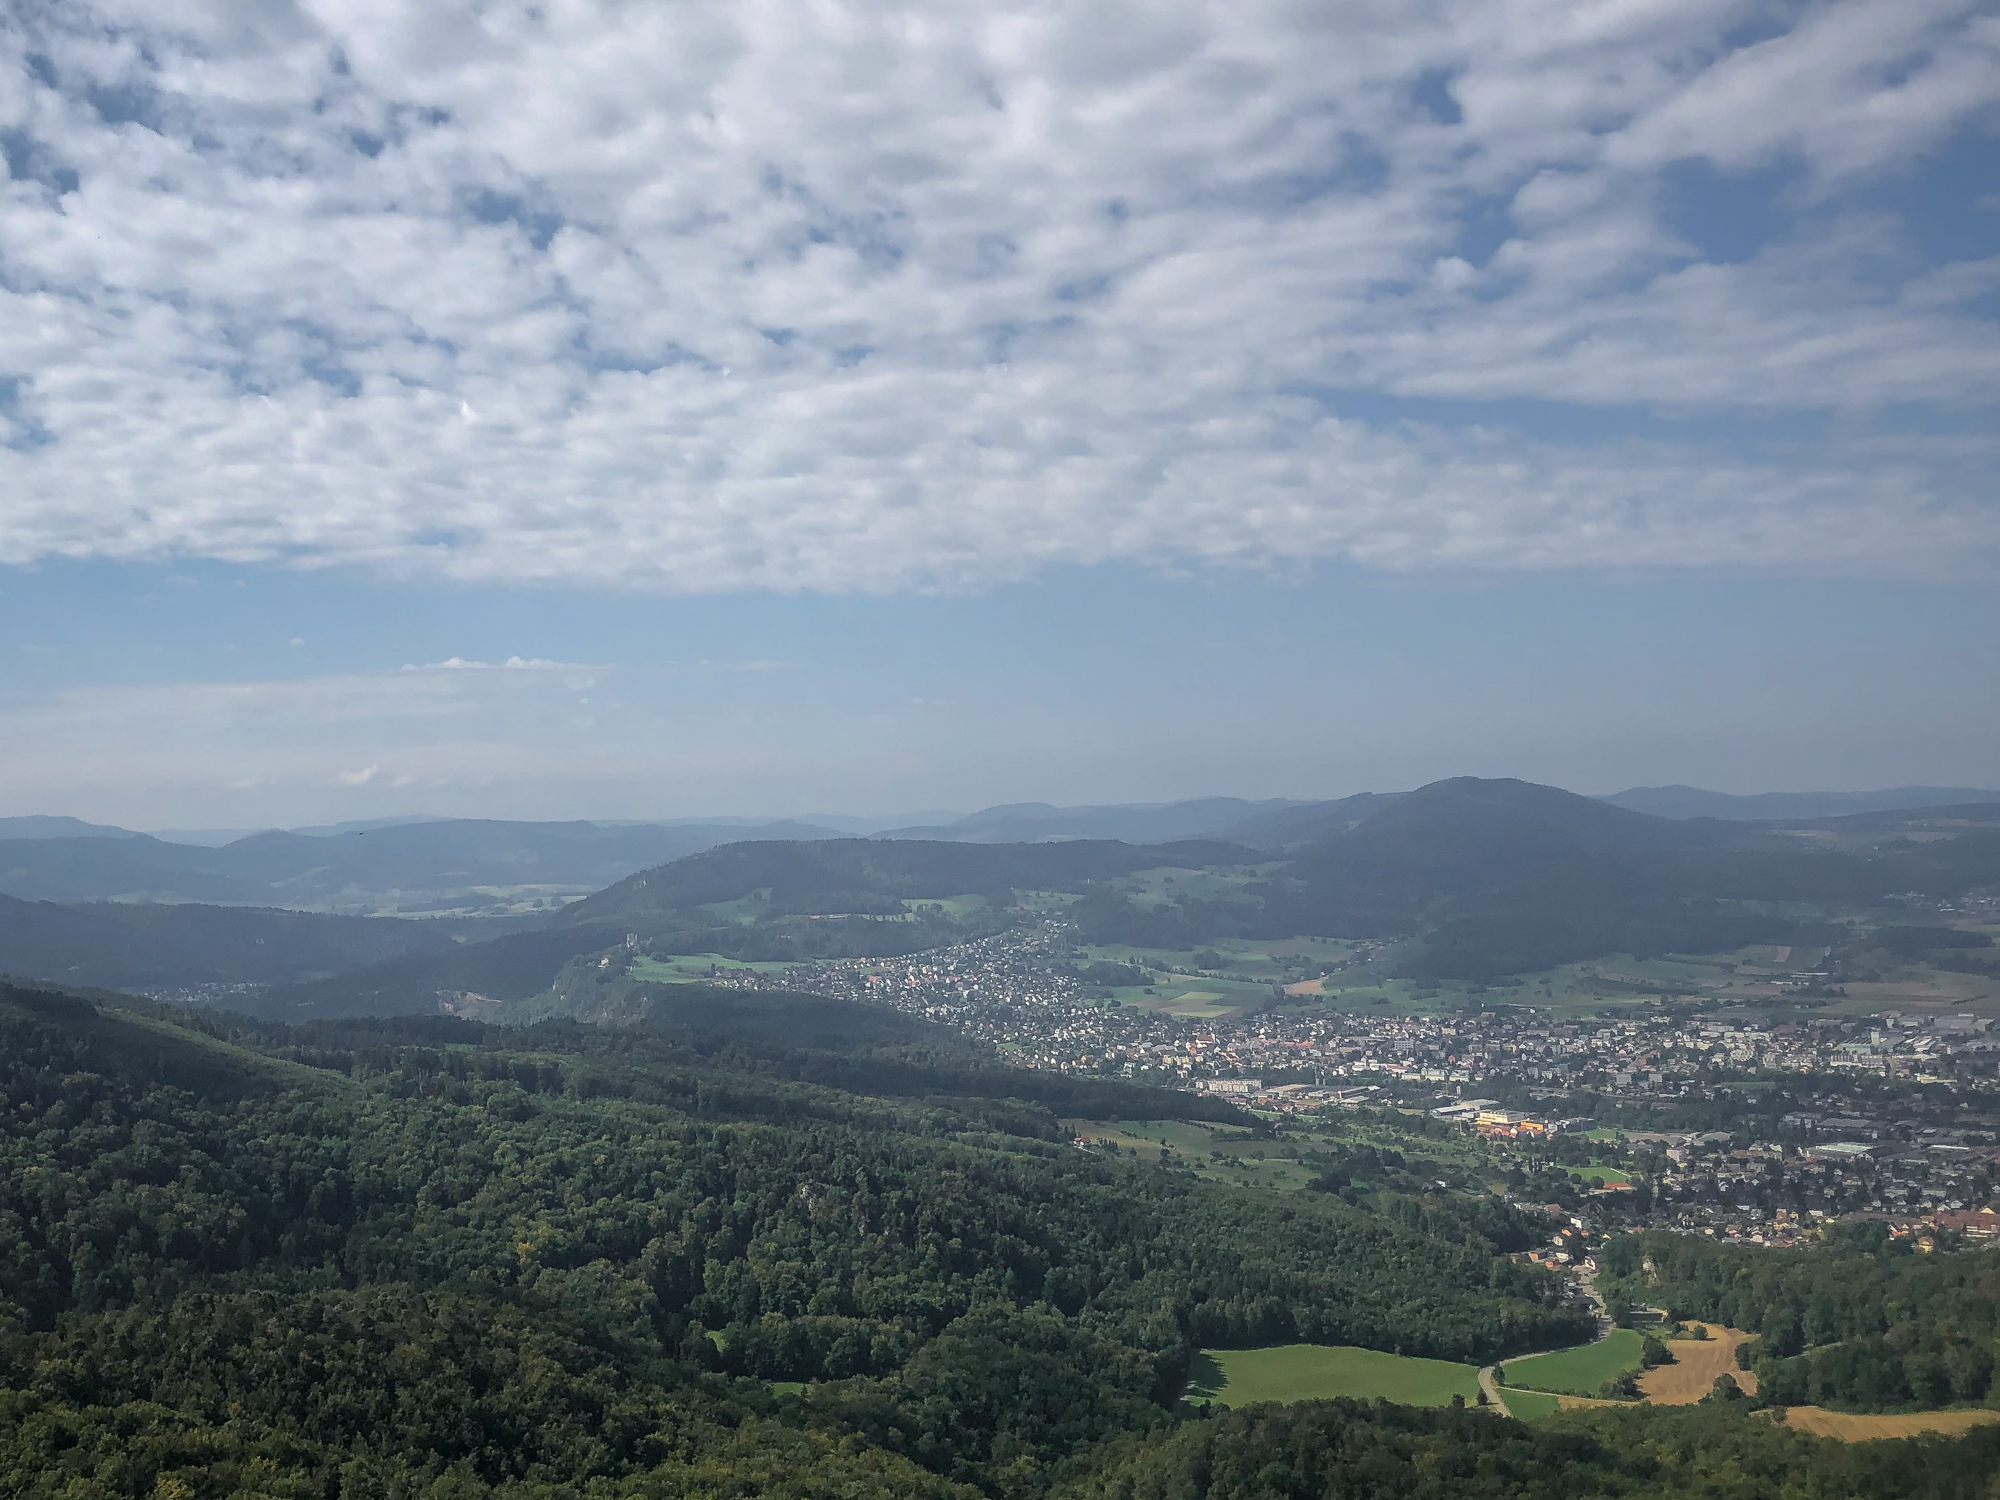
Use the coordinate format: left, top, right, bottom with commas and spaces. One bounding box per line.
1072, 778, 2000, 978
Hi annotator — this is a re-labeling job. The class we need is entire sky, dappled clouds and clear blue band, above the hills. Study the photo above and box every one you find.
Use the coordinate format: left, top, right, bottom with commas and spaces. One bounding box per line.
0, 0, 2000, 828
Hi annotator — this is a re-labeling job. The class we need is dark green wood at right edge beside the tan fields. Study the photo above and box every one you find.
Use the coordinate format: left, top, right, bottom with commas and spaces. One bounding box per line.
1598, 1224, 2000, 1412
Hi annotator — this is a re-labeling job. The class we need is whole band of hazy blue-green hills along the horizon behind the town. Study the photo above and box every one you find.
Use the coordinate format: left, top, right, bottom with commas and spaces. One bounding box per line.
0, 778, 2000, 1016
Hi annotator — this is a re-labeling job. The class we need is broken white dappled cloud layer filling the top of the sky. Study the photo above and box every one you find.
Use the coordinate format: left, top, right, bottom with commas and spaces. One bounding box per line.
0, 0, 2000, 592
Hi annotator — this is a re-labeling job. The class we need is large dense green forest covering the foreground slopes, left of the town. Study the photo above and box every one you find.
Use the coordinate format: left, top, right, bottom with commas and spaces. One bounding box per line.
0, 986, 2000, 1500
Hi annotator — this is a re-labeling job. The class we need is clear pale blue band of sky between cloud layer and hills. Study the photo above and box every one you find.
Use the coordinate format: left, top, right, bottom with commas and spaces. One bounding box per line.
0, 564, 2000, 826
